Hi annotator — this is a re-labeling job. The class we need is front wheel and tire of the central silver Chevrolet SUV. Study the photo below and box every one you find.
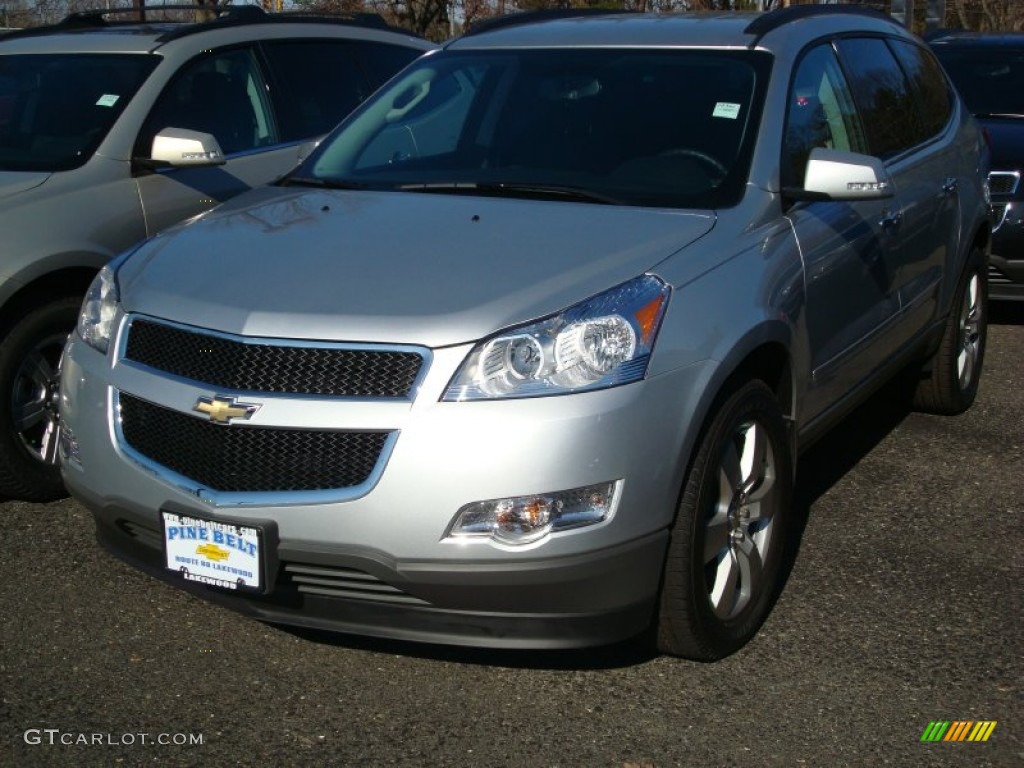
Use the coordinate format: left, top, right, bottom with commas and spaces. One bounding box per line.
656, 381, 793, 662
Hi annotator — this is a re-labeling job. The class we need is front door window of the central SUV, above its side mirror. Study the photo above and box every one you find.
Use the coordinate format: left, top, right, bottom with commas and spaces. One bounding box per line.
782, 44, 868, 186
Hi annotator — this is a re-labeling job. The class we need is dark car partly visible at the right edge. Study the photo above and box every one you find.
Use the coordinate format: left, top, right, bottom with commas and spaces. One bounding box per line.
930, 33, 1024, 301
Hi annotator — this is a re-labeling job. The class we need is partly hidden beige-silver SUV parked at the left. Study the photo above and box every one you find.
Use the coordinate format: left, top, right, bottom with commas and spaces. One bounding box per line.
0, 6, 433, 501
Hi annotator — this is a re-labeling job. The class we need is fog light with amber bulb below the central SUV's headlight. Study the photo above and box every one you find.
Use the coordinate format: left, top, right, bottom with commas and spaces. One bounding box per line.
446, 480, 622, 544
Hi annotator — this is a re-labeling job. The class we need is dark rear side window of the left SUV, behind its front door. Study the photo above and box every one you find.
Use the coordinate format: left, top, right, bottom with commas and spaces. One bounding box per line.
262, 40, 373, 141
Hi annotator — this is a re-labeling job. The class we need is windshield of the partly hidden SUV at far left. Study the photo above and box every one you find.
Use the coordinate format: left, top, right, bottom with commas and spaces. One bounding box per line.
0, 53, 158, 171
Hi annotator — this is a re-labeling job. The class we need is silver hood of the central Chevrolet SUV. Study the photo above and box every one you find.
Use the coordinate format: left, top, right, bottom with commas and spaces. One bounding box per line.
118, 187, 715, 347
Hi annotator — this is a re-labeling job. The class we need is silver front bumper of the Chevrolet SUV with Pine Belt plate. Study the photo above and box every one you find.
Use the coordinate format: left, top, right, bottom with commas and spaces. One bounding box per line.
61, 331, 708, 648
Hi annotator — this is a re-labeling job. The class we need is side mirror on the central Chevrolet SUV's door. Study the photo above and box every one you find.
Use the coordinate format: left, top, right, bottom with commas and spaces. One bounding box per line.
786, 147, 894, 201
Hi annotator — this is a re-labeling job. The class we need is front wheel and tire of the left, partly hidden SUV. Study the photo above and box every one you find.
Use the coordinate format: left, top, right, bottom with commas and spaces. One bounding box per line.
0, 297, 82, 502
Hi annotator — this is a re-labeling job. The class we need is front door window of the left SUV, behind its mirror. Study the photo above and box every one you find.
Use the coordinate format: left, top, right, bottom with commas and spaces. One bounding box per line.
135, 48, 279, 157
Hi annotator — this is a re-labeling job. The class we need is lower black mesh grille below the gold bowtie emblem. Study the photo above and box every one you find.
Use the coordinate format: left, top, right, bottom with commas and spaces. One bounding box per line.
120, 393, 389, 493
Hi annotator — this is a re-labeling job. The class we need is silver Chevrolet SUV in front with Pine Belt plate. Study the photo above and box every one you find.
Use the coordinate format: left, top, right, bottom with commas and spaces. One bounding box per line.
60, 6, 990, 659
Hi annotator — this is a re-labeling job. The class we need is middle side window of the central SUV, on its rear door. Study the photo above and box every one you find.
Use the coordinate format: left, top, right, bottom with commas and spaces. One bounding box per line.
836, 38, 925, 159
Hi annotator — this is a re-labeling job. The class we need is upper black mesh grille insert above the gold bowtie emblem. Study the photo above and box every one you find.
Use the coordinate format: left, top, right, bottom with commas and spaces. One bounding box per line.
125, 319, 423, 397
